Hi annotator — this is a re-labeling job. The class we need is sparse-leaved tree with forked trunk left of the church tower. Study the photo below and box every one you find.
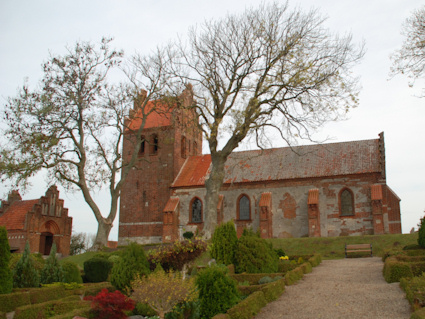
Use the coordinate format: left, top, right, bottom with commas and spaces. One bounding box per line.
0, 39, 172, 248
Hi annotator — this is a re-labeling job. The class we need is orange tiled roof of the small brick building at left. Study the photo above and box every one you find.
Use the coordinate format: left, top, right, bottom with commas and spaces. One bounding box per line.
0, 199, 38, 230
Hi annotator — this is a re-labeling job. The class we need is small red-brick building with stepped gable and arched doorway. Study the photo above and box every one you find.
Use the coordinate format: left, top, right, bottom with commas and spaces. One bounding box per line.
0, 186, 72, 256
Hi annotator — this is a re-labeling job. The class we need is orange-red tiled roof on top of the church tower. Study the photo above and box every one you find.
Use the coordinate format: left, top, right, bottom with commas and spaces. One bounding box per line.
128, 101, 172, 130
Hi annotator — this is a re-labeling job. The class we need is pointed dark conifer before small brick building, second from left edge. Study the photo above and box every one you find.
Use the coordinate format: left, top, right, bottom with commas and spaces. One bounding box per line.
13, 242, 40, 288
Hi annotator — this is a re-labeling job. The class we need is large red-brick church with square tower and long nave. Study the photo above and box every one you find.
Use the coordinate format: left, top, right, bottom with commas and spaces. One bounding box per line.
118, 90, 401, 245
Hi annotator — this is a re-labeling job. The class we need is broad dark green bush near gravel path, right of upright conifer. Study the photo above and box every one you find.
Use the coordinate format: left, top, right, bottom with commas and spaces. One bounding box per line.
235, 235, 279, 273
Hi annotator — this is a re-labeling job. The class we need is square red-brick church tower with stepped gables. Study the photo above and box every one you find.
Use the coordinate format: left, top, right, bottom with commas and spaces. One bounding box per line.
118, 86, 202, 245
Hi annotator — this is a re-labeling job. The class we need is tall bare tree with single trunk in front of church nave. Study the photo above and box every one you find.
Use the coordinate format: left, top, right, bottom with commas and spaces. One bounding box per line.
173, 3, 363, 237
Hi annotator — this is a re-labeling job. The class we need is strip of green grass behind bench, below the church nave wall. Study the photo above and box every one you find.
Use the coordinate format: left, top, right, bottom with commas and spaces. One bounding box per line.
268, 233, 418, 259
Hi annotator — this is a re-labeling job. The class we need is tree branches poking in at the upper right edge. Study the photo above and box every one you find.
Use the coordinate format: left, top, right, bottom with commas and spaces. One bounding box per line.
391, 6, 425, 95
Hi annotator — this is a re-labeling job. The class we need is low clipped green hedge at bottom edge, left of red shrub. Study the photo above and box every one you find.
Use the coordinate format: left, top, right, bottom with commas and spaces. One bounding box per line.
13, 296, 84, 319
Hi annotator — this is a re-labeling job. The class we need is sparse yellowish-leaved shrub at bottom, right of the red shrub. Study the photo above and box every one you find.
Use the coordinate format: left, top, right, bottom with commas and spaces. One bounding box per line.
131, 267, 196, 318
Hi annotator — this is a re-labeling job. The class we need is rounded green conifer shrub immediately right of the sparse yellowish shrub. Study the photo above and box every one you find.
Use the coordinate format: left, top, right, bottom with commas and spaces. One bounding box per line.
196, 266, 239, 318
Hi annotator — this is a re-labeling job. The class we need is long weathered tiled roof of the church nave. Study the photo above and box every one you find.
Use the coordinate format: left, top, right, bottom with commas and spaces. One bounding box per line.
172, 139, 381, 187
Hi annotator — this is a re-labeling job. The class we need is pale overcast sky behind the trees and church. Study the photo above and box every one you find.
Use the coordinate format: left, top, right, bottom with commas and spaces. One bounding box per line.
0, 0, 425, 240
